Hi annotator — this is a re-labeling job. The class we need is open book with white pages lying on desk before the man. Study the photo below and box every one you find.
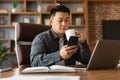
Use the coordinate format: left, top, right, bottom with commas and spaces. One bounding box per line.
22, 65, 76, 73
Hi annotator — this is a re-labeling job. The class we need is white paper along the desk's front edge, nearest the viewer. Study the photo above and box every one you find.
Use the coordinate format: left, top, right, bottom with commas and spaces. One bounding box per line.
0, 75, 80, 80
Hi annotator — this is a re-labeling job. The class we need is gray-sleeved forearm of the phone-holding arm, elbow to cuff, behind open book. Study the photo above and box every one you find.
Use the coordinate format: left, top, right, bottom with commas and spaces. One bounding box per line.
31, 51, 60, 66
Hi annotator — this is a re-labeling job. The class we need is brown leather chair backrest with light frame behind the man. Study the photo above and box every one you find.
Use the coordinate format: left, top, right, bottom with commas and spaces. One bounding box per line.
15, 23, 51, 68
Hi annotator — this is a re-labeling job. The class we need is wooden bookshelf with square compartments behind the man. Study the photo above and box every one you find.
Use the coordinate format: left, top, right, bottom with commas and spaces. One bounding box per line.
0, 0, 89, 67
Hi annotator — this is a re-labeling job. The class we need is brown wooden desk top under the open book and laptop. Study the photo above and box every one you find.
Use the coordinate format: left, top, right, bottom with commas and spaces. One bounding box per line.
0, 68, 120, 80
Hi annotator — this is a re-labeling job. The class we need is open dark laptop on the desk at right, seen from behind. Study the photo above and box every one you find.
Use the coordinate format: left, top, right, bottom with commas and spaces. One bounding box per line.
77, 40, 120, 70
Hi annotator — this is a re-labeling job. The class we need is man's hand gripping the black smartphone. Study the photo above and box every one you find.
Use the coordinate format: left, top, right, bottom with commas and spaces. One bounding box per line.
60, 45, 77, 59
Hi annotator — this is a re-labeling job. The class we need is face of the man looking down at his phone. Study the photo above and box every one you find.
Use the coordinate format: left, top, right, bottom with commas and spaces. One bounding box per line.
50, 12, 70, 35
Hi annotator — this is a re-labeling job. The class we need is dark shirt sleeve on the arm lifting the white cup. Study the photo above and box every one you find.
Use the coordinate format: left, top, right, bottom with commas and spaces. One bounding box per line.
76, 41, 91, 64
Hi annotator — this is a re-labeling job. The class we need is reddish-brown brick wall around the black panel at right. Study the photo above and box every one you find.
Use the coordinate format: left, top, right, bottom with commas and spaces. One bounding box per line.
88, 2, 120, 48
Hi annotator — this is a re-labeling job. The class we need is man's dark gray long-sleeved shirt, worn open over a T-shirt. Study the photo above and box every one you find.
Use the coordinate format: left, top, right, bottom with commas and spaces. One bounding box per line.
30, 29, 91, 66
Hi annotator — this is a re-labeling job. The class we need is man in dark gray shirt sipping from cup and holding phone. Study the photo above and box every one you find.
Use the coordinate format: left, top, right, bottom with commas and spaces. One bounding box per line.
30, 5, 91, 66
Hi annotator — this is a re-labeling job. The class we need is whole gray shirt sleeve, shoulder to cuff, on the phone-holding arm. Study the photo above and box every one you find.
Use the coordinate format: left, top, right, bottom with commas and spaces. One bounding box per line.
30, 36, 60, 66
